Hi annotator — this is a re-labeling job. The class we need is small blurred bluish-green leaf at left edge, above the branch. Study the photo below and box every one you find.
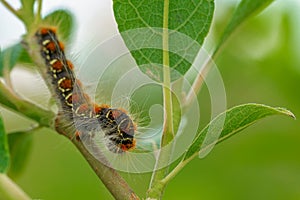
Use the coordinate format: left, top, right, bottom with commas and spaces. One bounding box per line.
0, 43, 23, 76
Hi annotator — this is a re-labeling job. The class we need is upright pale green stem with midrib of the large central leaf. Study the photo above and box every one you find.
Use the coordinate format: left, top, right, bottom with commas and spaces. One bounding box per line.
147, 0, 174, 199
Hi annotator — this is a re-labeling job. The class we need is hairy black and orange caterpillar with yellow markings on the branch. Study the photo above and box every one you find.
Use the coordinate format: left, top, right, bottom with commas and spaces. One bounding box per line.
35, 27, 136, 153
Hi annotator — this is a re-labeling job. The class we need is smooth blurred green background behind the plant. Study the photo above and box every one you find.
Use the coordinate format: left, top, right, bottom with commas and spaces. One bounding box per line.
0, 0, 300, 200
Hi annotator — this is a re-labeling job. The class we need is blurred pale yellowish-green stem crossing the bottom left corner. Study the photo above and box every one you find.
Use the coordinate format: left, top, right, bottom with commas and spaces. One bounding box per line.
0, 174, 31, 200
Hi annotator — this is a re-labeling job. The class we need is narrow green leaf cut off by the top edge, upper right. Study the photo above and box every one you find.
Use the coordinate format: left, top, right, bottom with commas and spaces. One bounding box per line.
215, 0, 275, 53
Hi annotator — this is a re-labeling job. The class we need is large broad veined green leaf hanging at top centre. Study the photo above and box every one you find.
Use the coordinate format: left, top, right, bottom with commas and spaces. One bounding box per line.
113, 0, 214, 81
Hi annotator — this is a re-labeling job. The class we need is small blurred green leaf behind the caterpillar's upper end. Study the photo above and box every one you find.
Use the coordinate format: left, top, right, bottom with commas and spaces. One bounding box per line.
44, 10, 74, 42
